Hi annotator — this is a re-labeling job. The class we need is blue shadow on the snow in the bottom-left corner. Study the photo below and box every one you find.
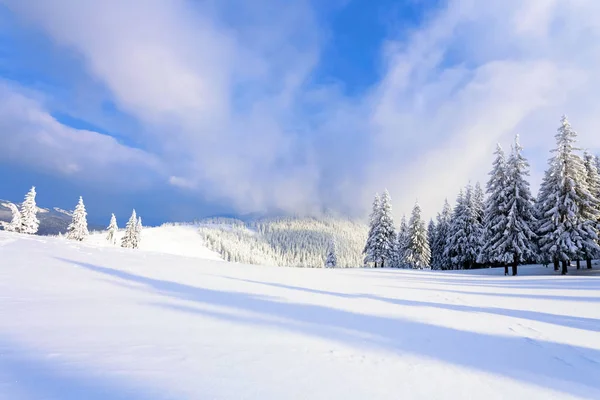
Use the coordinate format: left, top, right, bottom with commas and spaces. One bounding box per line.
0, 338, 162, 400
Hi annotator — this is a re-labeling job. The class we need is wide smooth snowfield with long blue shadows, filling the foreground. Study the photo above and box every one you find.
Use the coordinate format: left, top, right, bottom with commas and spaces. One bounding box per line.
0, 230, 600, 400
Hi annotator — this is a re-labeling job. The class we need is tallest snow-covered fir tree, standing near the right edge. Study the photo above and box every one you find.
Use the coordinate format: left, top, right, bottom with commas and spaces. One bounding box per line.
537, 116, 599, 274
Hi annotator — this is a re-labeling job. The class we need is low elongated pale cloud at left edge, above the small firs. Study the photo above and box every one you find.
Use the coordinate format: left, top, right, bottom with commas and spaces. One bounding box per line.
0, 81, 162, 189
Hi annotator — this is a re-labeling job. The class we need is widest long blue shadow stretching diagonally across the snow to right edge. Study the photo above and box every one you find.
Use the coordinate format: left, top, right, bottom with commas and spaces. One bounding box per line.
61, 259, 600, 398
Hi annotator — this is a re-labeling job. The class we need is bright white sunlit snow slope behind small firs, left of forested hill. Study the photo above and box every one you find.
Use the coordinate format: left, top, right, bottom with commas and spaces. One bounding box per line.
86, 224, 222, 260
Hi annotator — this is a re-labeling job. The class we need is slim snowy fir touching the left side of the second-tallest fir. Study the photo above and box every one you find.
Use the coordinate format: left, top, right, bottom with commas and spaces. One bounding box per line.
478, 144, 508, 274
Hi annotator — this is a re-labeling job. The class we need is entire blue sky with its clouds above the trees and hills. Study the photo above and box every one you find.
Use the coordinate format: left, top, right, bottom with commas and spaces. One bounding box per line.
0, 0, 600, 224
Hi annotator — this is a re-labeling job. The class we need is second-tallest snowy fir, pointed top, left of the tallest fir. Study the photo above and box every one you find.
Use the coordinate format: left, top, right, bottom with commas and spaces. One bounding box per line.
497, 135, 537, 275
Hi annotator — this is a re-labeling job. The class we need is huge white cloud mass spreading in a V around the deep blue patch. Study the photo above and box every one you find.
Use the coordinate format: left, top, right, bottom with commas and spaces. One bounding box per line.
1, 0, 600, 219
